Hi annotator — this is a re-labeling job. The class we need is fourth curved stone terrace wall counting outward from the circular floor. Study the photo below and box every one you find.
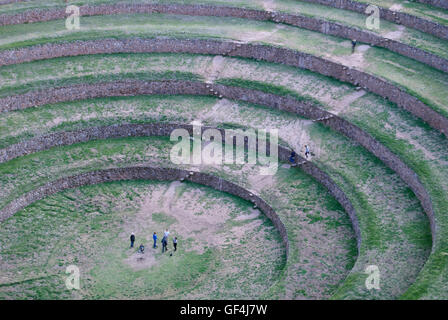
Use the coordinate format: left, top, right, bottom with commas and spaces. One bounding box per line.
0, 38, 448, 136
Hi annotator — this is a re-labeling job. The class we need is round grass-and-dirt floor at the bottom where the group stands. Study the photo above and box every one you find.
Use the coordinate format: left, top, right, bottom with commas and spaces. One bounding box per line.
0, 181, 285, 299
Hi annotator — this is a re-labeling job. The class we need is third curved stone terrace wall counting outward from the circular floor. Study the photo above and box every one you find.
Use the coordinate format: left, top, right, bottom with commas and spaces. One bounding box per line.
0, 80, 438, 248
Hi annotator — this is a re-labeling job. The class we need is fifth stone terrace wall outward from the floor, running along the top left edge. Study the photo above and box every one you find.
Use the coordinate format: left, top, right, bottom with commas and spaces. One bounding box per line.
0, 3, 448, 72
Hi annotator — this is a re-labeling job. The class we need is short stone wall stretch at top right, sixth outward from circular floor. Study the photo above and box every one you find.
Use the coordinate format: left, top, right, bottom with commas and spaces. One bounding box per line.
301, 0, 448, 40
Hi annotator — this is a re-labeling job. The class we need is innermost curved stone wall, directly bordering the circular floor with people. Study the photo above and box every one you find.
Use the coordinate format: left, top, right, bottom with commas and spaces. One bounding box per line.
0, 167, 289, 257
